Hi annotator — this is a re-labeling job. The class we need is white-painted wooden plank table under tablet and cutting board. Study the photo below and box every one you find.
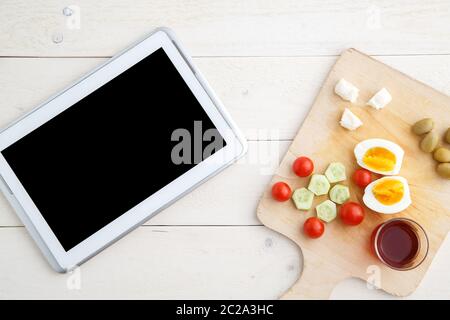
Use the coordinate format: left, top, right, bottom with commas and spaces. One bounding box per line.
0, 0, 450, 299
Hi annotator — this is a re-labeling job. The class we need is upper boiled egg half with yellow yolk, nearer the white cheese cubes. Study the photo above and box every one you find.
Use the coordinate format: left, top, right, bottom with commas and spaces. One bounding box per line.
354, 139, 405, 175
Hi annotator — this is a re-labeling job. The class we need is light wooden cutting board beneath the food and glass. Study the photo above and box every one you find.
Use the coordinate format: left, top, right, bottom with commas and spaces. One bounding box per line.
257, 49, 450, 299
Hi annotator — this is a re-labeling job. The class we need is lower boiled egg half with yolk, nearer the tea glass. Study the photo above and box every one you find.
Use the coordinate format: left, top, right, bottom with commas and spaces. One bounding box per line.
363, 176, 411, 214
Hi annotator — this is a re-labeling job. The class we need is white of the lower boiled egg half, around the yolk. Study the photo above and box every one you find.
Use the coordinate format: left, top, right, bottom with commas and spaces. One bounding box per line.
363, 176, 412, 214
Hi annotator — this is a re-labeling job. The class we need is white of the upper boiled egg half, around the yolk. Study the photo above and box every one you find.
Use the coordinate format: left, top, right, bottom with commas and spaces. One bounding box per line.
353, 139, 405, 176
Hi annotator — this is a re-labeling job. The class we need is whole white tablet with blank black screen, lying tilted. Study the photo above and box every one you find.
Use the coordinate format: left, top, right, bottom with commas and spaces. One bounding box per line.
0, 29, 246, 272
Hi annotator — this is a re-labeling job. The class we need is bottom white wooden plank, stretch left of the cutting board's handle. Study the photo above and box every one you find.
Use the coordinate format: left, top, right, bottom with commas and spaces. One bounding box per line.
0, 227, 299, 299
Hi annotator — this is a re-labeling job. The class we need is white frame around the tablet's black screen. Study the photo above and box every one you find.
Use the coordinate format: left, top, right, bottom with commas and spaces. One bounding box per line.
0, 28, 247, 272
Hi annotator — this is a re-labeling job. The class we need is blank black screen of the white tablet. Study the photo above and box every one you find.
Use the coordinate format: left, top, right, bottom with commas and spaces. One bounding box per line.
2, 49, 225, 250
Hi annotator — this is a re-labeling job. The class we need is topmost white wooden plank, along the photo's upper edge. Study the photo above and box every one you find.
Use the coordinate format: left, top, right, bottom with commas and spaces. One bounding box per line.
0, 0, 450, 56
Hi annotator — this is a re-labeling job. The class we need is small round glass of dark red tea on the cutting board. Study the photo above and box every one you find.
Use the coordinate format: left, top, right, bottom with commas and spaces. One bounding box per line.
371, 218, 428, 270
